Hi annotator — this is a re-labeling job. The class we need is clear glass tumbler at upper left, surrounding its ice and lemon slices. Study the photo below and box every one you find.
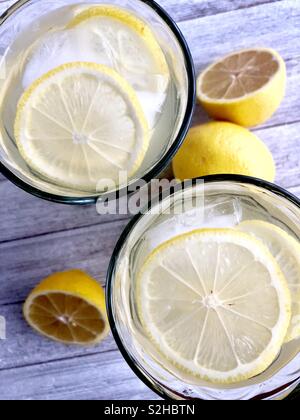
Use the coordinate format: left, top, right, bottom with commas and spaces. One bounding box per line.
0, 0, 195, 204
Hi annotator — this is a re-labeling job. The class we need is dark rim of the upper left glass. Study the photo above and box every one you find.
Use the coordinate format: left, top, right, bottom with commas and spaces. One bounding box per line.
0, 0, 196, 205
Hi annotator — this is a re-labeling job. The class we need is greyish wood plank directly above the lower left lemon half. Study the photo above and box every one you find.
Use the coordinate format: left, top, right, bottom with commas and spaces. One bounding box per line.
0, 221, 127, 305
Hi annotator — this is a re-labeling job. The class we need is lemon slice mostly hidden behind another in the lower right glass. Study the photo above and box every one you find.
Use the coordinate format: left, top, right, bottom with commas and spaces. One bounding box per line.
238, 220, 300, 342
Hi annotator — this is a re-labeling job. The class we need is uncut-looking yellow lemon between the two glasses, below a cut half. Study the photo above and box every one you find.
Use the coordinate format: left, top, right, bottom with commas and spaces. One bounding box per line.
173, 121, 276, 182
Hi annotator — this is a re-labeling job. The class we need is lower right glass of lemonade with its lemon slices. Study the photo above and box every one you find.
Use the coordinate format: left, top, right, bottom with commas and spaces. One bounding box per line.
107, 175, 300, 400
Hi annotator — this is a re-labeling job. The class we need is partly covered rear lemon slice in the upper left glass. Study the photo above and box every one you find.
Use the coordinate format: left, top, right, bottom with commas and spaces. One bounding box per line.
67, 5, 170, 128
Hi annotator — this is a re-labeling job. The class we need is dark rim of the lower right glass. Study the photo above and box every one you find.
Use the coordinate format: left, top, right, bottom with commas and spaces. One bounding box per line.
106, 174, 300, 400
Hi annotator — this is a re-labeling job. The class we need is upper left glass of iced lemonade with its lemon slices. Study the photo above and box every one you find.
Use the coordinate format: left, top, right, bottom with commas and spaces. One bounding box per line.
0, 0, 195, 204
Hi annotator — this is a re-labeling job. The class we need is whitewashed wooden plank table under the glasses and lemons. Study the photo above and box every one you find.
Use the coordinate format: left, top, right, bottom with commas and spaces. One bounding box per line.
0, 0, 300, 399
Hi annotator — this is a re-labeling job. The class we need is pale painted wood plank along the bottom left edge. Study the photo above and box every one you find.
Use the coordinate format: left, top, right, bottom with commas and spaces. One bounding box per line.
0, 352, 158, 400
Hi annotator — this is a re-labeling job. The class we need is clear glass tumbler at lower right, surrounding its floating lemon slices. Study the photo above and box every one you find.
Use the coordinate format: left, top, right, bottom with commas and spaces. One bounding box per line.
107, 175, 300, 400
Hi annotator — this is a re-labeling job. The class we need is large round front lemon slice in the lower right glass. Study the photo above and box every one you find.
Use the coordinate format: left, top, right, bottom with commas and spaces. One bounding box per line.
136, 229, 291, 384
